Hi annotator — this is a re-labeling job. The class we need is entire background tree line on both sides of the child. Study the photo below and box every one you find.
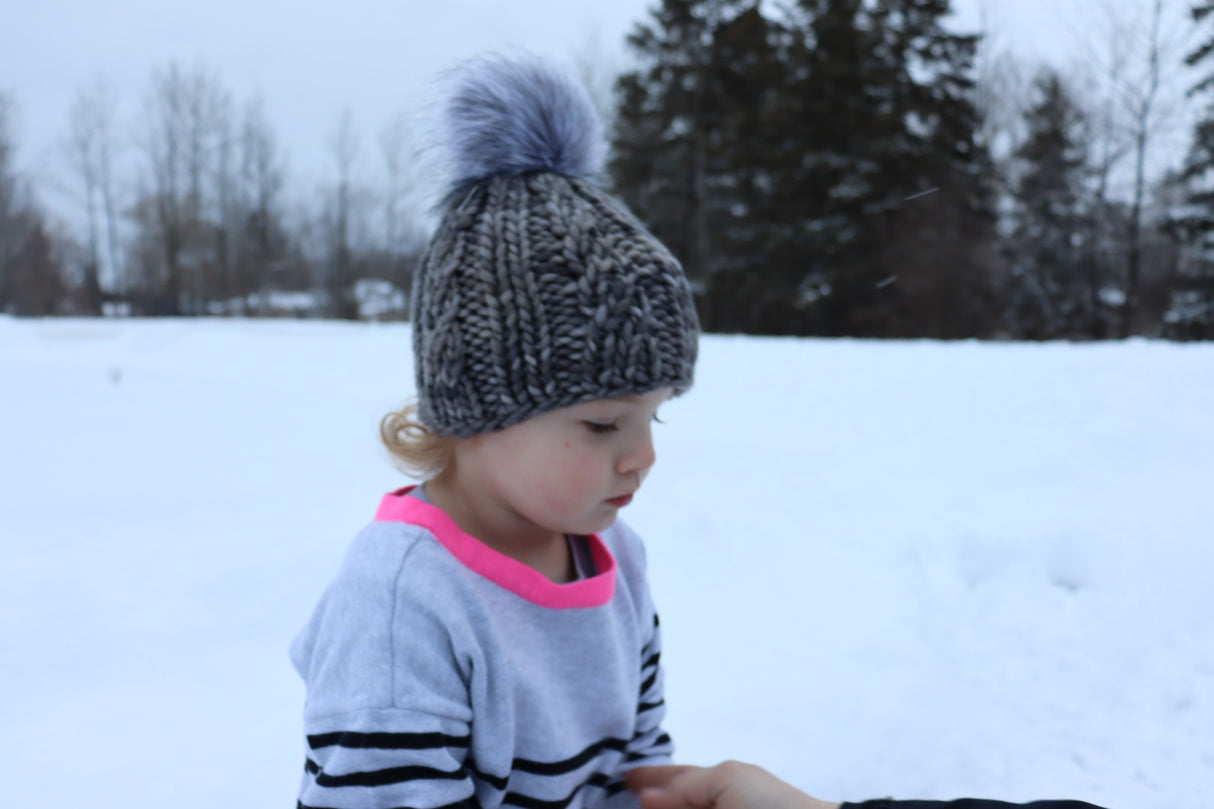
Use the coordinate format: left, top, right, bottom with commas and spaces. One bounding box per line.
0, 0, 1214, 339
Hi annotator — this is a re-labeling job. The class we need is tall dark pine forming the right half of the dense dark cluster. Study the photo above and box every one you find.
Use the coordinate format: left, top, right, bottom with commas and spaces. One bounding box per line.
793, 0, 994, 336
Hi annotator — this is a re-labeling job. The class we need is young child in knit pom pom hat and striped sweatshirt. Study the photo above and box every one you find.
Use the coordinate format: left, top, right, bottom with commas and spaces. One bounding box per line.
291, 58, 698, 809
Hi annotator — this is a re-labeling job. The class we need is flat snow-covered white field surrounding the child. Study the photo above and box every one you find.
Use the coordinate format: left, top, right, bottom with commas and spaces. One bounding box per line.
0, 319, 1214, 809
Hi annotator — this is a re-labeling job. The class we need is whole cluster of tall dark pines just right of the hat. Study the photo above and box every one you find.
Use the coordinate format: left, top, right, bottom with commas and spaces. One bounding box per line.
612, 0, 993, 336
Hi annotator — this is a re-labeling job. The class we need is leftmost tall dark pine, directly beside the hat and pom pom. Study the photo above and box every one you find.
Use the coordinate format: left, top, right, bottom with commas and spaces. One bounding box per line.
611, 0, 761, 330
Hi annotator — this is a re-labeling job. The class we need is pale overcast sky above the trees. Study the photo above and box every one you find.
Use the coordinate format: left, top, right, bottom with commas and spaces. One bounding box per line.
0, 0, 1175, 218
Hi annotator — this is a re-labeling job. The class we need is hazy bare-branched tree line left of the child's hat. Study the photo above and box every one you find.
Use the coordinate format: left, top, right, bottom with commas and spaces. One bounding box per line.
0, 63, 424, 318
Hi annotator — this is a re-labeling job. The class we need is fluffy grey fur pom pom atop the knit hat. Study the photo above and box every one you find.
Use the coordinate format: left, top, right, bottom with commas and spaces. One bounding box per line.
443, 56, 607, 193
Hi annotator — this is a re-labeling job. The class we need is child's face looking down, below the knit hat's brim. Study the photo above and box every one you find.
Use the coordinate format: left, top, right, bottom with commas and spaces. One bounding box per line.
456, 389, 670, 537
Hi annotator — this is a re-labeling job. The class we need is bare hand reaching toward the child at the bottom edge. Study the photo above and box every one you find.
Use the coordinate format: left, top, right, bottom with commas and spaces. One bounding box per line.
628, 762, 839, 809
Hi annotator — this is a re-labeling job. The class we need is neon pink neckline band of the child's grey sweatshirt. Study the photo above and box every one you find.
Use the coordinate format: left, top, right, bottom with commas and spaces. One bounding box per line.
375, 486, 615, 610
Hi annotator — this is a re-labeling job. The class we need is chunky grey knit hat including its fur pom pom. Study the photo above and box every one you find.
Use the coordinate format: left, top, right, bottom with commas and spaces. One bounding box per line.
412, 57, 699, 437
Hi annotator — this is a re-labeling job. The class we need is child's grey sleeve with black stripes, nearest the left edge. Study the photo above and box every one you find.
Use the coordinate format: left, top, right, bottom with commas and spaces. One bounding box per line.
293, 534, 477, 809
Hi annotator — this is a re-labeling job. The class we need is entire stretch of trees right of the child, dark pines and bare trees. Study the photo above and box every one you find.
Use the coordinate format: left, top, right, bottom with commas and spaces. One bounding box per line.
612, 0, 1214, 339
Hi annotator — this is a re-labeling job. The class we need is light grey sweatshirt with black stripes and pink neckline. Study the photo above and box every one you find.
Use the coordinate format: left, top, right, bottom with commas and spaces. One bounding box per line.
291, 488, 671, 809
